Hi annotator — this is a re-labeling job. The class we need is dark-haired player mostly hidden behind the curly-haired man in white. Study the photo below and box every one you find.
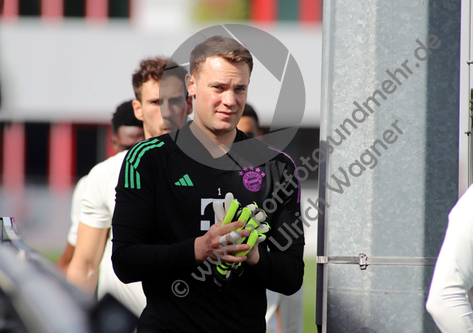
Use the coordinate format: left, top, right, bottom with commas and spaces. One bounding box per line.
56, 100, 144, 274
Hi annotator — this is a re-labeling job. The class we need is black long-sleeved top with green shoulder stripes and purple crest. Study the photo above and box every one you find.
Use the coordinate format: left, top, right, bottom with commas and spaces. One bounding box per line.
112, 124, 304, 333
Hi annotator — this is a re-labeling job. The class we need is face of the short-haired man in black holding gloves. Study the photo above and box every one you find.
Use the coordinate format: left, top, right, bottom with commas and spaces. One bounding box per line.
188, 56, 250, 136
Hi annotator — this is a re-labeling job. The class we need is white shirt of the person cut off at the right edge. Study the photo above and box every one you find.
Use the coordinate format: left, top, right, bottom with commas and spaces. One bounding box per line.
426, 186, 473, 333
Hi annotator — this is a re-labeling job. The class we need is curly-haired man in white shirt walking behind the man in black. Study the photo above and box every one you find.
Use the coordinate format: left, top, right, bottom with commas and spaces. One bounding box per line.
67, 57, 192, 316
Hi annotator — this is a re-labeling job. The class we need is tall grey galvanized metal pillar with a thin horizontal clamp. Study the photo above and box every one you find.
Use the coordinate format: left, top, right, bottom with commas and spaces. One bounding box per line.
316, 0, 461, 333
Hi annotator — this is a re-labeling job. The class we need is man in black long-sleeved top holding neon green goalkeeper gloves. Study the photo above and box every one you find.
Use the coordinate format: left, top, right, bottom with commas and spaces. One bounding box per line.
112, 36, 304, 333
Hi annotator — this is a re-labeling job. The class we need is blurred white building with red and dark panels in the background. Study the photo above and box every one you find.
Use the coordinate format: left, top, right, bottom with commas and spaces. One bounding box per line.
0, 0, 322, 249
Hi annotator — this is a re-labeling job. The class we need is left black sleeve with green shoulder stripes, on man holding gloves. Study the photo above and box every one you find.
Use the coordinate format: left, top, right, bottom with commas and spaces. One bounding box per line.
112, 146, 195, 283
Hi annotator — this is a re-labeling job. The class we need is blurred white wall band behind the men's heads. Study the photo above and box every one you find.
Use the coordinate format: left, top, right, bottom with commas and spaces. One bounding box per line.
0, 19, 322, 127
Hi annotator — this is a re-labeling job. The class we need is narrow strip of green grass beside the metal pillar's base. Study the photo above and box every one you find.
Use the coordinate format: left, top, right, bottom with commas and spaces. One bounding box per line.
303, 258, 317, 333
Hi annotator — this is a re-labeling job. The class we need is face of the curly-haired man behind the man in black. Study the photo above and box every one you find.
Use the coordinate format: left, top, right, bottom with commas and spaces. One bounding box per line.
133, 76, 192, 139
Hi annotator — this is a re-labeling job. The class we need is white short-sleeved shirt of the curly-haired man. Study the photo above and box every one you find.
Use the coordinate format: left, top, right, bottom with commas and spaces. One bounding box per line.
80, 151, 146, 316
